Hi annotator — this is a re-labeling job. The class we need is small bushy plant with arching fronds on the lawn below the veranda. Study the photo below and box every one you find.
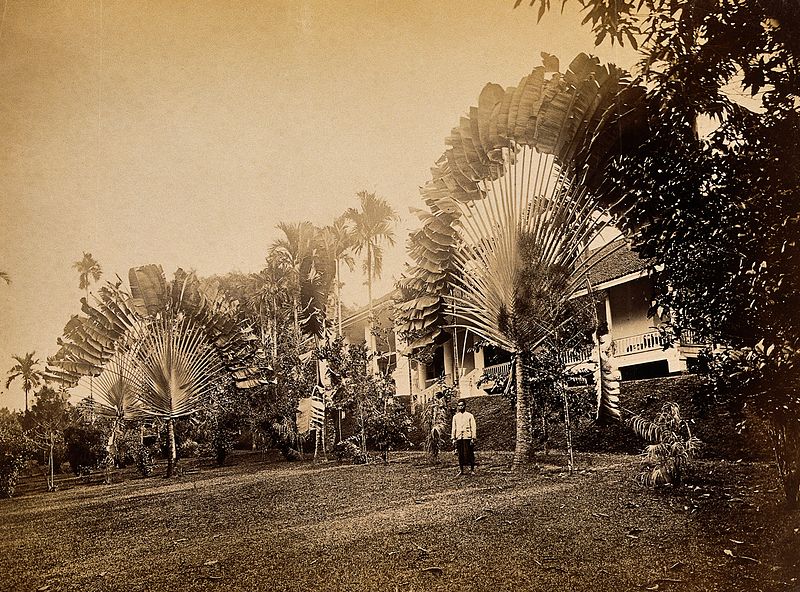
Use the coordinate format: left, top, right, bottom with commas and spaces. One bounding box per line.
630, 402, 700, 487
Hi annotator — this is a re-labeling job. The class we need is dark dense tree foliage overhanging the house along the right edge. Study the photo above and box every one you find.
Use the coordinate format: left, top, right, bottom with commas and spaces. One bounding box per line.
517, 0, 800, 504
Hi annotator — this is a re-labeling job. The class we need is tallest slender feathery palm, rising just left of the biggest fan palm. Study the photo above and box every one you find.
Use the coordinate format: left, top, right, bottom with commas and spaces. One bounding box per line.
344, 191, 400, 352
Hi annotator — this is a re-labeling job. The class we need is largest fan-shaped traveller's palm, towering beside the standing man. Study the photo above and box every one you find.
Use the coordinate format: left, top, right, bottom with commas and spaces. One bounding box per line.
400, 54, 636, 465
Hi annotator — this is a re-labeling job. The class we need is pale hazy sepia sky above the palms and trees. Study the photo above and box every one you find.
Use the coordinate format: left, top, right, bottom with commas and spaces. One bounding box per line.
0, 0, 635, 408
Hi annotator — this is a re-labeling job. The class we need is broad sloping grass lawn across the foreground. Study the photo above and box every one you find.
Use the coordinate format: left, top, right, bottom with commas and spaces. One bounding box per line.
0, 451, 800, 592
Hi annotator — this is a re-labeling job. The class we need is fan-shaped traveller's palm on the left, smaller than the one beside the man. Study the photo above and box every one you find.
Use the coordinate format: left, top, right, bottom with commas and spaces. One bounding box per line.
46, 265, 266, 472
